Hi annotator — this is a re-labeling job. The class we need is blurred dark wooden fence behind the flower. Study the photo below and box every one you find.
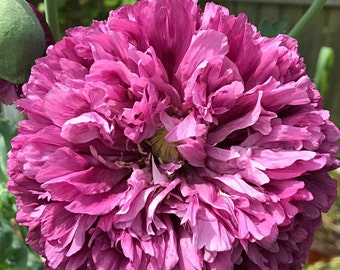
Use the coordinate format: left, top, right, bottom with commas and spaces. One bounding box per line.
201, 0, 340, 126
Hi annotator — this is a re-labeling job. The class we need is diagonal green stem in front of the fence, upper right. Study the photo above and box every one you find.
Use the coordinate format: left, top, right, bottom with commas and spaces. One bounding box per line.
289, 0, 327, 38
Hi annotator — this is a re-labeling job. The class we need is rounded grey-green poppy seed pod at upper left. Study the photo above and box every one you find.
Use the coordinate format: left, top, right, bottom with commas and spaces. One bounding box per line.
0, 0, 46, 84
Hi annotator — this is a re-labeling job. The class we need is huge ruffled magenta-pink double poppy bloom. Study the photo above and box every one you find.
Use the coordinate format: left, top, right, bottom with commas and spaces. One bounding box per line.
8, 0, 339, 270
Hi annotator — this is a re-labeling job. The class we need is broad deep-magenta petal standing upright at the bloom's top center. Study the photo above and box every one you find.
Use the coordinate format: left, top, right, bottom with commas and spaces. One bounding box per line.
127, 0, 199, 74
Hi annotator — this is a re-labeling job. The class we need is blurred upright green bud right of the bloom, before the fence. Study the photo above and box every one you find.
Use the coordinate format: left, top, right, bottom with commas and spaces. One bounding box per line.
314, 46, 335, 97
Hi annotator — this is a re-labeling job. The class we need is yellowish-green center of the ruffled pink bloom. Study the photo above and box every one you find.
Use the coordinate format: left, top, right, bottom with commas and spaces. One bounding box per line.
150, 128, 178, 164
